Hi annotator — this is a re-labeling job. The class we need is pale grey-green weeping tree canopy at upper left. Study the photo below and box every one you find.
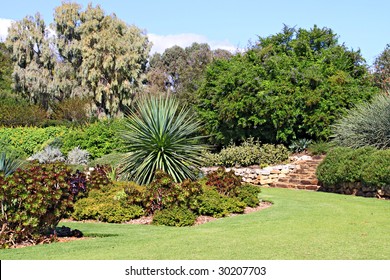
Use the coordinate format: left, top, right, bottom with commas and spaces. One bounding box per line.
6, 2, 150, 116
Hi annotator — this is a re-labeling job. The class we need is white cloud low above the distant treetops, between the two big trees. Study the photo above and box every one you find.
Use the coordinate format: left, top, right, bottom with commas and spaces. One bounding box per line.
147, 33, 240, 53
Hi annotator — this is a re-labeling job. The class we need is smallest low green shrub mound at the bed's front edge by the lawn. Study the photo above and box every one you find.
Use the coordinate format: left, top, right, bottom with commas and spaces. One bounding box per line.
153, 206, 196, 227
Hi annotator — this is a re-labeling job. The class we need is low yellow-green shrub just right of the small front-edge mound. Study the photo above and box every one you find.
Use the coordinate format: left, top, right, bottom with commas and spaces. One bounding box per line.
196, 189, 246, 218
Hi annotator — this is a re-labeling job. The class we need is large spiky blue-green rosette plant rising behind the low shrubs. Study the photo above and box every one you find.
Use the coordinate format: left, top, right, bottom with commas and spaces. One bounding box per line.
120, 96, 206, 184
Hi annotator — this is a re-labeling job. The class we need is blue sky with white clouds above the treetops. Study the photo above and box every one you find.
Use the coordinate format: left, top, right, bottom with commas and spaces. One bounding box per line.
0, 0, 390, 64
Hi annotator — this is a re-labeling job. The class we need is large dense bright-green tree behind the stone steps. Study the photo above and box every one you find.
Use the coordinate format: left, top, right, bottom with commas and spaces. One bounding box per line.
197, 26, 377, 145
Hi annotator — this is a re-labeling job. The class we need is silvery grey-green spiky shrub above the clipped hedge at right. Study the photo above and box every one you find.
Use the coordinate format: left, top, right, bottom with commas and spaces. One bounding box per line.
333, 95, 390, 149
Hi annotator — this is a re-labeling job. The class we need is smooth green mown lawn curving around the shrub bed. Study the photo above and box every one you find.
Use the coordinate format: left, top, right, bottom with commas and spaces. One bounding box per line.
0, 189, 390, 260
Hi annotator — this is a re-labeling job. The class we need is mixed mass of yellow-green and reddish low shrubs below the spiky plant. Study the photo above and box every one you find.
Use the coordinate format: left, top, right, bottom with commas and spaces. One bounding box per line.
72, 168, 260, 226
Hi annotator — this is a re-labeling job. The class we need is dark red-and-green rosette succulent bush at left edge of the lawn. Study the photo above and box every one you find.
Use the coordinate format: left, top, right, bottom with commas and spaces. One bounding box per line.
0, 163, 75, 247
